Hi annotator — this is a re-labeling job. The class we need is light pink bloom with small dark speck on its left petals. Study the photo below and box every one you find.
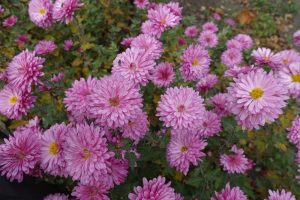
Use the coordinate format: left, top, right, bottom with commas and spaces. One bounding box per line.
112, 48, 155, 85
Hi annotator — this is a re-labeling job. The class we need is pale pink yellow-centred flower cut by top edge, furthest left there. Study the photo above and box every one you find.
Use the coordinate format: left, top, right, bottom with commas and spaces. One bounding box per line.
28, 0, 53, 28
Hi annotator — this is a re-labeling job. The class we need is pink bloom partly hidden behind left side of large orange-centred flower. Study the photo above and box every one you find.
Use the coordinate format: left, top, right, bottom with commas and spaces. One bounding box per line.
64, 76, 98, 122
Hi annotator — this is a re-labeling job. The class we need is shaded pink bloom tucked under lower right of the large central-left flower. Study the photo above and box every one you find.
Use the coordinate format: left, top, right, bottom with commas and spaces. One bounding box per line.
121, 110, 149, 143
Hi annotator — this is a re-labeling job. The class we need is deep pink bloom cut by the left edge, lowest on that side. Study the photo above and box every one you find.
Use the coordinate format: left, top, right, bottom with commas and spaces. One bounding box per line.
0, 130, 40, 182
